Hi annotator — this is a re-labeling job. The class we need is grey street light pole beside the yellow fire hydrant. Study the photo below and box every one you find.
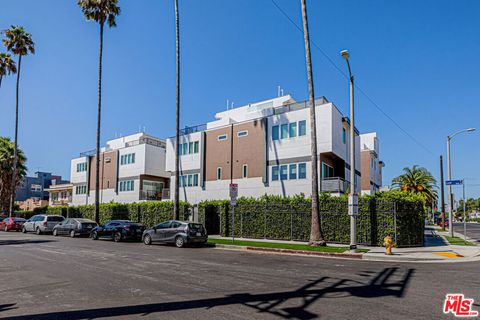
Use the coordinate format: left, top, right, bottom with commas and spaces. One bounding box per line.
340, 50, 358, 250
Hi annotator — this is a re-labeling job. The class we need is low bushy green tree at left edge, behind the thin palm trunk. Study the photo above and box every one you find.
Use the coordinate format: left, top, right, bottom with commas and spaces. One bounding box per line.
0, 137, 27, 212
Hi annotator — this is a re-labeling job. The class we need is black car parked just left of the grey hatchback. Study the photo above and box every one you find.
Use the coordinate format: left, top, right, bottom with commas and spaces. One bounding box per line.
90, 220, 145, 242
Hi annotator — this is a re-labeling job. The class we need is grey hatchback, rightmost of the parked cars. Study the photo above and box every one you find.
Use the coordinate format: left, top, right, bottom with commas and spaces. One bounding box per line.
142, 220, 208, 248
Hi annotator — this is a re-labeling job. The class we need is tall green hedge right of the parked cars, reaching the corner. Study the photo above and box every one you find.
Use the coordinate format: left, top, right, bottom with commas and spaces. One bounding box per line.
199, 191, 425, 246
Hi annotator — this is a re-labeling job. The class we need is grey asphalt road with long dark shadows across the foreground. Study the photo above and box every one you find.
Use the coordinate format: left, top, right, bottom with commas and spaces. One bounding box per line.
0, 232, 480, 320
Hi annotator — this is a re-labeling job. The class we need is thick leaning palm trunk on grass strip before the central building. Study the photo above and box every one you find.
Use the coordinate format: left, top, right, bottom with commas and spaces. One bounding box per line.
301, 0, 326, 246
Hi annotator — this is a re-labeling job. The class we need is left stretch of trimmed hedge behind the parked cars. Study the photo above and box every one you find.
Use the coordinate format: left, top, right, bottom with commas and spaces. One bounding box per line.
13, 201, 190, 227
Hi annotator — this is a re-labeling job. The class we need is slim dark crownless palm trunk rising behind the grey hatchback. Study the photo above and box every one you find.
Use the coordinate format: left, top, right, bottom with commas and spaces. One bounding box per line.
173, 0, 180, 220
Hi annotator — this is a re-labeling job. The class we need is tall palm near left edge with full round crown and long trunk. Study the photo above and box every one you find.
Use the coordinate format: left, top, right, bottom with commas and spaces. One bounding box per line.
3, 26, 35, 217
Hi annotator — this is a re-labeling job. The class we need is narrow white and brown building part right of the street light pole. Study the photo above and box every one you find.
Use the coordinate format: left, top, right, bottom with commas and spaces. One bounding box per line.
360, 132, 385, 195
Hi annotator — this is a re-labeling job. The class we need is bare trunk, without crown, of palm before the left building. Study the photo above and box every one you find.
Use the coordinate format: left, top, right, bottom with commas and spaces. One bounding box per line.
95, 23, 103, 223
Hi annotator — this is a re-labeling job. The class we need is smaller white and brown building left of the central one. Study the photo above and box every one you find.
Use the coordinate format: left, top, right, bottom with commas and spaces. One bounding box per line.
70, 133, 170, 205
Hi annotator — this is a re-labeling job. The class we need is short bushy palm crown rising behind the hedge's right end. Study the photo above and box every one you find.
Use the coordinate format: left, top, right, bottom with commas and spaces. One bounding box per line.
392, 165, 438, 206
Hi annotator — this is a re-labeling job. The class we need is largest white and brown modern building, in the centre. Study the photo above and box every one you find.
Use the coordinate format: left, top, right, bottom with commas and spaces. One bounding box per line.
166, 95, 361, 203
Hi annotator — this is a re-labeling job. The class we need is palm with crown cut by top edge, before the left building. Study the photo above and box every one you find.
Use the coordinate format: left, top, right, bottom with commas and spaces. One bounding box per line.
77, 0, 120, 223
